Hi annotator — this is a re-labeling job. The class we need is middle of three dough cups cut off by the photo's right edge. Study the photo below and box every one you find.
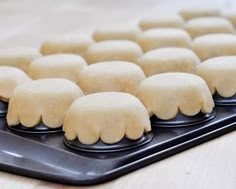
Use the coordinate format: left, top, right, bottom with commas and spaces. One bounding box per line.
192, 34, 236, 61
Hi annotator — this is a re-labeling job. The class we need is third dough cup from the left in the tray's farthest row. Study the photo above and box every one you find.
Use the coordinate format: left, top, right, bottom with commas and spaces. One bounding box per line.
93, 27, 141, 41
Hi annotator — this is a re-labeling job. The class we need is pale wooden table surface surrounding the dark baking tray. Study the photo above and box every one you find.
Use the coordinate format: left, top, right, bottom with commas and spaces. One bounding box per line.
0, 0, 236, 189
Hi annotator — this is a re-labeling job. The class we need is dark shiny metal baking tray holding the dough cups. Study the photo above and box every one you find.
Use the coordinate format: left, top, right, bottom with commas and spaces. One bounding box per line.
0, 106, 236, 185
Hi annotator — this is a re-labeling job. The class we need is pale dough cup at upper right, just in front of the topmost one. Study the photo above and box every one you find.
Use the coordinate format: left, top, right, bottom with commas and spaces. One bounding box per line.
184, 17, 234, 38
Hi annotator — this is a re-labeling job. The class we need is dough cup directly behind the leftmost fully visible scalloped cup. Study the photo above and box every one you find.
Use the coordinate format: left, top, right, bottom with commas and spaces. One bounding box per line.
28, 54, 87, 83
